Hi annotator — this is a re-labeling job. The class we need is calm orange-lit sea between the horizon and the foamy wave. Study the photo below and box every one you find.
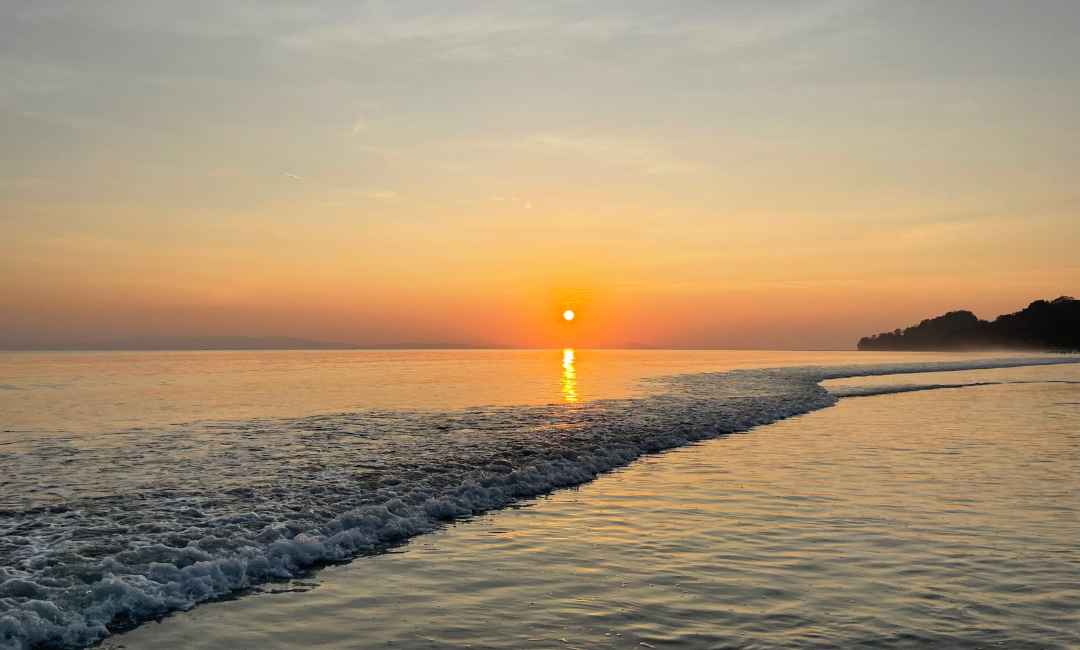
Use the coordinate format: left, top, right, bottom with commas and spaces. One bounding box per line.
0, 350, 1041, 431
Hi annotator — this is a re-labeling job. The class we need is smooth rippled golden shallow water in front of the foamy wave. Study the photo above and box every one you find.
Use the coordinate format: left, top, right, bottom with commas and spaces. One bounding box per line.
110, 366, 1080, 650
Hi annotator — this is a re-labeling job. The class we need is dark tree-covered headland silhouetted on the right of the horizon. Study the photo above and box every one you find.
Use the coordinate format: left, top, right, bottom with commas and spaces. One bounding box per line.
859, 296, 1080, 352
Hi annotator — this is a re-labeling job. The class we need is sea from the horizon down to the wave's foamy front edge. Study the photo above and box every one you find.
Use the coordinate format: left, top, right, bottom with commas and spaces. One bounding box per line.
0, 351, 1076, 648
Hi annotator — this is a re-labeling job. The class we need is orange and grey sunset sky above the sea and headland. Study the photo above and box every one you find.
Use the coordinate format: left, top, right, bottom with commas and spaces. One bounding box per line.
0, 0, 1080, 348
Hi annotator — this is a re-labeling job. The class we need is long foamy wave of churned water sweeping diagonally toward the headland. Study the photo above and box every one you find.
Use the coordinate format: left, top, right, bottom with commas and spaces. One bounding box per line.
0, 357, 1080, 649
